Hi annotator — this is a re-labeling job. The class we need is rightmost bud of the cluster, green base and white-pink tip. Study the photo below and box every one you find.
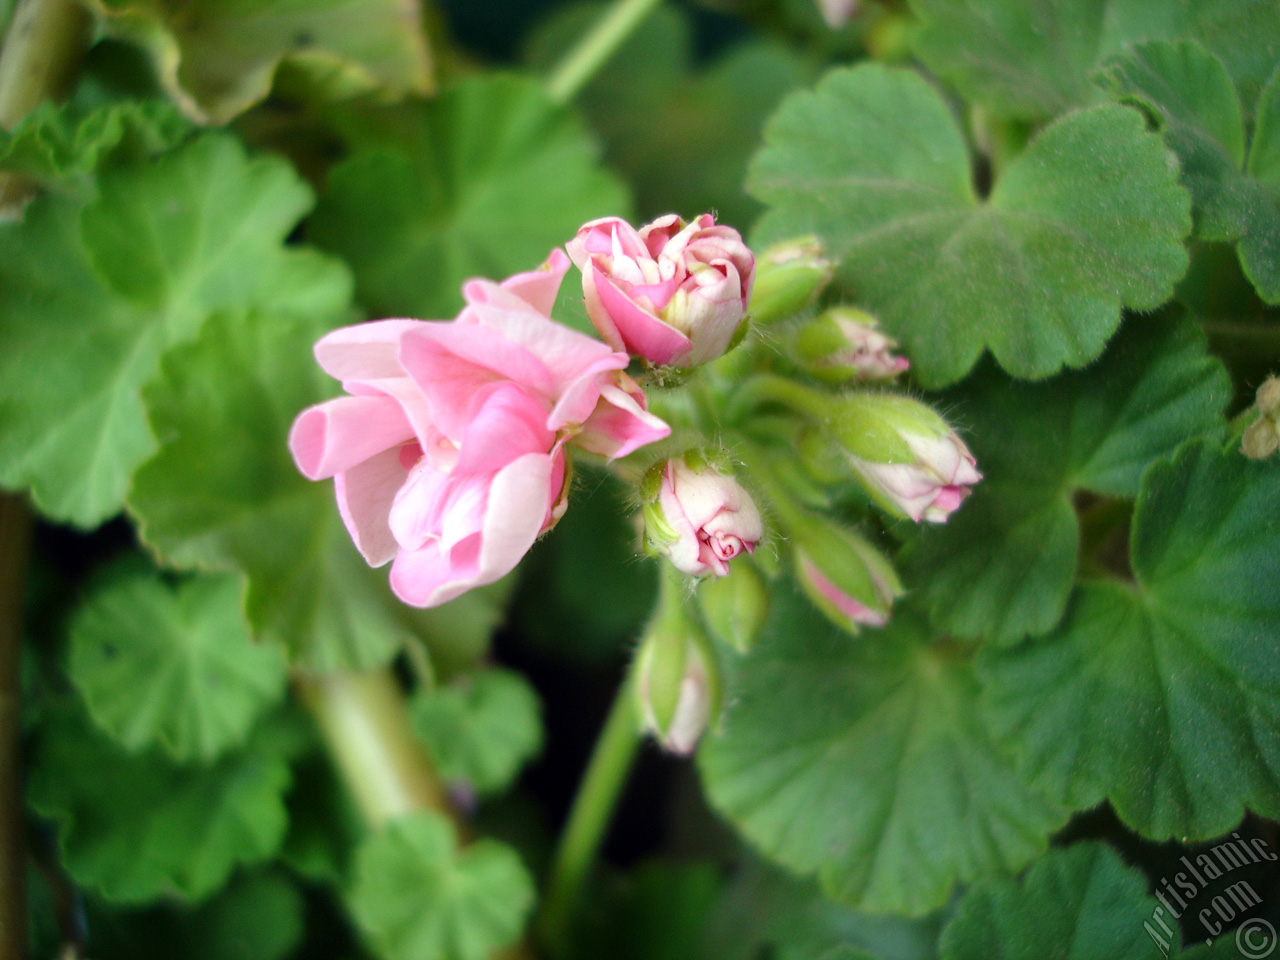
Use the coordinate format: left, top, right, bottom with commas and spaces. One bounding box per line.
828, 393, 982, 524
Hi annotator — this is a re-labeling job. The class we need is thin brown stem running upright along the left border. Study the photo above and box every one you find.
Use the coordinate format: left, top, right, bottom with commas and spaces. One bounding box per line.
0, 494, 31, 960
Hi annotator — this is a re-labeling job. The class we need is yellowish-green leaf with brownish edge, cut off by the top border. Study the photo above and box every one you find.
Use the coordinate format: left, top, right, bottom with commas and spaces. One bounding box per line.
95, 0, 431, 124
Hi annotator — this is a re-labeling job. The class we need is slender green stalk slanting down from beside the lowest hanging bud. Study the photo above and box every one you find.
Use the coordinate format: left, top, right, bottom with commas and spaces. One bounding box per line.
539, 672, 643, 956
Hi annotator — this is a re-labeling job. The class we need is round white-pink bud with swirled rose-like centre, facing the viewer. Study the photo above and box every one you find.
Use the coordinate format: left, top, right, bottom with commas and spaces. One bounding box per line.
641, 451, 764, 576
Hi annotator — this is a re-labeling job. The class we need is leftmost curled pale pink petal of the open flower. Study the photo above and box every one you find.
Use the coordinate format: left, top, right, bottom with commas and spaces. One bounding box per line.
289, 397, 413, 480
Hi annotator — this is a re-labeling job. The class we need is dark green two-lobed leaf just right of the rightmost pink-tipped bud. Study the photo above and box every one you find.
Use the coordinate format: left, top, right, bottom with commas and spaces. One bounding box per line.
902, 316, 1231, 643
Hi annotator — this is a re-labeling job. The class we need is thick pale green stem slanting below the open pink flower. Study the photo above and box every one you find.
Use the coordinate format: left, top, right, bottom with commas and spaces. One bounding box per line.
298, 669, 451, 829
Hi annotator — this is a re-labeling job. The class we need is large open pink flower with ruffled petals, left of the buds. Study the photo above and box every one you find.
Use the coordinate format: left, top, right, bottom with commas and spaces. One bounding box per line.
289, 251, 669, 607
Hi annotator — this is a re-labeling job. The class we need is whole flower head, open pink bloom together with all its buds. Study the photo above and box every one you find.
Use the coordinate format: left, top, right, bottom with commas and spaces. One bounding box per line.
291, 208, 983, 754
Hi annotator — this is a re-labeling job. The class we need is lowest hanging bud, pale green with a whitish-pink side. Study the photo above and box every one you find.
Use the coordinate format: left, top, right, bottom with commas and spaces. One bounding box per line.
636, 589, 721, 755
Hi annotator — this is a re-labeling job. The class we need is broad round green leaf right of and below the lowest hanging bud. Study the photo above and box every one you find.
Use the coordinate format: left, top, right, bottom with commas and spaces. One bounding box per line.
701, 586, 1066, 914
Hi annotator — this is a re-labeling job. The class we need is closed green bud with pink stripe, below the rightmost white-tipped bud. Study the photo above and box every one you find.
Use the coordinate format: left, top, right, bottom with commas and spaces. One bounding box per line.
787, 517, 902, 634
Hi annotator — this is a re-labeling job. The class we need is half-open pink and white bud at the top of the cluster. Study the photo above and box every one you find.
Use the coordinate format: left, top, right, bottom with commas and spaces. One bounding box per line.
567, 214, 755, 366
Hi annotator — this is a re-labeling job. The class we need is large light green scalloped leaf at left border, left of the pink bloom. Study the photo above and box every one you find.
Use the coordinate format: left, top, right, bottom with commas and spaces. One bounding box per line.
0, 134, 325, 526
